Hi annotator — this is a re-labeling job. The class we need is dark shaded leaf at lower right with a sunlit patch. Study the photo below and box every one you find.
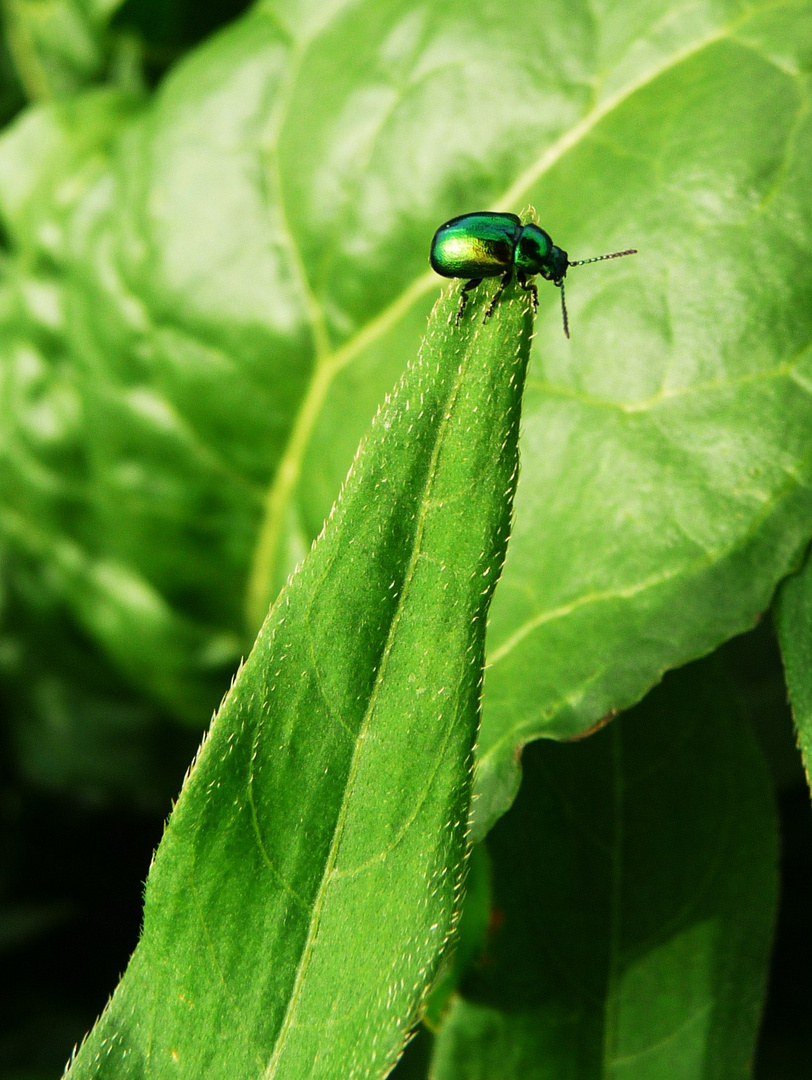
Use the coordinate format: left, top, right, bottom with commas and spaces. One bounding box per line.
430, 648, 777, 1080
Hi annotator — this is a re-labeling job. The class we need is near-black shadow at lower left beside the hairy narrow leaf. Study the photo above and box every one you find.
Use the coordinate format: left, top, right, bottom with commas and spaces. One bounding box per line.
0, 708, 198, 1080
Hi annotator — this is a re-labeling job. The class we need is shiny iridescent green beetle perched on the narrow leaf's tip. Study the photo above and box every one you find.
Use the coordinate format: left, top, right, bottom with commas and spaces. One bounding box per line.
429, 211, 637, 337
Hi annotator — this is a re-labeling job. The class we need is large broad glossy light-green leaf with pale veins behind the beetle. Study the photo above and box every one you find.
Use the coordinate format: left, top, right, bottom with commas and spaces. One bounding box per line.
0, 0, 812, 833
